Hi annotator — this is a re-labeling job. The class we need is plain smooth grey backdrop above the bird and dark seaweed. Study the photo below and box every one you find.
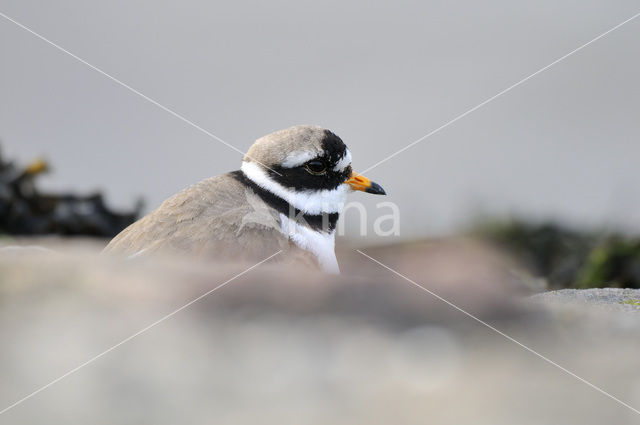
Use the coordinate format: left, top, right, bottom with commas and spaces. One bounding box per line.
0, 0, 640, 242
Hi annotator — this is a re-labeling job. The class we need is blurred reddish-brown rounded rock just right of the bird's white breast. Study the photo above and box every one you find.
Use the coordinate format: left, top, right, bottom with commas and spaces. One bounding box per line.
338, 238, 544, 315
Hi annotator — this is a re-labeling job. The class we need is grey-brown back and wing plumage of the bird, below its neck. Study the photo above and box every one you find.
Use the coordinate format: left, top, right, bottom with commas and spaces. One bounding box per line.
105, 174, 317, 265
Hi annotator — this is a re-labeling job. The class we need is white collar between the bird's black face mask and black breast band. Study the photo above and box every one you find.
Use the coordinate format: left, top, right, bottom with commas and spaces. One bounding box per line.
240, 161, 351, 214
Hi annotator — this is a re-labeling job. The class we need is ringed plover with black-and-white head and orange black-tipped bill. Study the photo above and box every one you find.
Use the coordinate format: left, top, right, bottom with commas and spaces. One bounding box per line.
103, 125, 386, 273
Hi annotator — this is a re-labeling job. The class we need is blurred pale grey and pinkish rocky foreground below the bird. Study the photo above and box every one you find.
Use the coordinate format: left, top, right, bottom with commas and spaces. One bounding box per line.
0, 241, 640, 425
